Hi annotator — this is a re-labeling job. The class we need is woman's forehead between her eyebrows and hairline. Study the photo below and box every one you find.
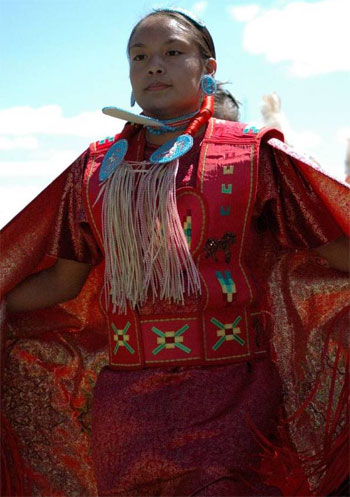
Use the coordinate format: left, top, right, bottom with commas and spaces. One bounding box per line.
130, 16, 193, 48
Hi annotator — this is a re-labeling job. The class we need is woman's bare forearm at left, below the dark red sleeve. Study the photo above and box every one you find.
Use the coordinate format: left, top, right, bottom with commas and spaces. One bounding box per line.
6, 259, 91, 312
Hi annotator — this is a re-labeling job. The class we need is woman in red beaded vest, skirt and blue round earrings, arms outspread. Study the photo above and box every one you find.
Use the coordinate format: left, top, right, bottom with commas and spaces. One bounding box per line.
1, 9, 346, 496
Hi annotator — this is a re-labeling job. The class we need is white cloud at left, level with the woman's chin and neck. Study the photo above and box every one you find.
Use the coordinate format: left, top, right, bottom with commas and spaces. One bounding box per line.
0, 105, 124, 139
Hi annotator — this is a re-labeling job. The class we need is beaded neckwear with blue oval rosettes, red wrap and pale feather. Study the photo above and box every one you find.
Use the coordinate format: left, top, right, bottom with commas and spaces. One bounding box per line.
99, 96, 214, 182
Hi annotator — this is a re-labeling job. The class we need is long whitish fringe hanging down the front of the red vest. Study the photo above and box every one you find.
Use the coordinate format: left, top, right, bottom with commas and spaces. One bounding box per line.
102, 161, 200, 312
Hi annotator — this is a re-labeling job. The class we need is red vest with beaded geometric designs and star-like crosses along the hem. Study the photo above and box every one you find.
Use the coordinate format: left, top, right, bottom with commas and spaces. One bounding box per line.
85, 119, 280, 370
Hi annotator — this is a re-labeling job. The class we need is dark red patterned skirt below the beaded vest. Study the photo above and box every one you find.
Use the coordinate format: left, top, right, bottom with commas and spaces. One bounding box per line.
92, 360, 281, 497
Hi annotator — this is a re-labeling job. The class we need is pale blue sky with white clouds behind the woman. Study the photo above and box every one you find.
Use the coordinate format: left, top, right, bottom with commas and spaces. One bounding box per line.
0, 0, 350, 227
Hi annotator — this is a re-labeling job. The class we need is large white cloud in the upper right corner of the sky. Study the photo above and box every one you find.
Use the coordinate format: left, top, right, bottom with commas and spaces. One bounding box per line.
230, 0, 350, 78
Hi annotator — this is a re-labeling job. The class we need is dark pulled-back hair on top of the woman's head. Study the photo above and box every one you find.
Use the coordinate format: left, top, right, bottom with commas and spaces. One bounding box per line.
127, 9, 216, 60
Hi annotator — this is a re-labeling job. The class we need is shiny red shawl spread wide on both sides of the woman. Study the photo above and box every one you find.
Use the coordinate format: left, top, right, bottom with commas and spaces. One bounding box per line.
1, 140, 350, 497
